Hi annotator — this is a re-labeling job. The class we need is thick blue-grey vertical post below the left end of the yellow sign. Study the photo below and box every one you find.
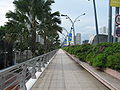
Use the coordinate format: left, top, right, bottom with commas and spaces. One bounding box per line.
108, 0, 112, 42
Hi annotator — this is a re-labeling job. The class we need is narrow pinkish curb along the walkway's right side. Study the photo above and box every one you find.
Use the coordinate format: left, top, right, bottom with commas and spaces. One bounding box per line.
63, 50, 118, 90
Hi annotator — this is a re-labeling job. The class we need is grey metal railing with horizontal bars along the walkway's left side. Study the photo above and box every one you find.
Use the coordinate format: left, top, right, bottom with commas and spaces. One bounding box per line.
0, 50, 57, 90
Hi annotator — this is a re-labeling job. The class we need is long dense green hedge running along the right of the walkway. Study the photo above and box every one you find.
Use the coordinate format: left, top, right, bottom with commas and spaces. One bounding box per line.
64, 43, 120, 70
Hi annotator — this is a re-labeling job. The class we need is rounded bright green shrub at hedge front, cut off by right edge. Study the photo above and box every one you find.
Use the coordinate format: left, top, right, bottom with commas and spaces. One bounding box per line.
106, 53, 120, 70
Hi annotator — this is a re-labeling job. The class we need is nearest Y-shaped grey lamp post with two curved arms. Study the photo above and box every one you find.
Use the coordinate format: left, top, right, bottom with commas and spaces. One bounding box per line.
61, 13, 85, 45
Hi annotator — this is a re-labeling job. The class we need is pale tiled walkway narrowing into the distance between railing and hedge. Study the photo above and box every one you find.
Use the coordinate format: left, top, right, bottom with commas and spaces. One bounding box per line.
32, 50, 109, 90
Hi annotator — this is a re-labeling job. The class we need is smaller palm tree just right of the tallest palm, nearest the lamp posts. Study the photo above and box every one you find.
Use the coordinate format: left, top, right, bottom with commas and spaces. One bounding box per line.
39, 11, 62, 53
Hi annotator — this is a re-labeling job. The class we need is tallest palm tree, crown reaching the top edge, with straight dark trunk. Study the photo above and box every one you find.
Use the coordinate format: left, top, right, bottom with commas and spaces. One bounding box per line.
14, 0, 53, 56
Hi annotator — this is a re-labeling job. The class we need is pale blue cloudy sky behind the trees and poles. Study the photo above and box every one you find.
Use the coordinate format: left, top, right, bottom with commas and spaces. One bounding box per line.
0, 0, 114, 41
